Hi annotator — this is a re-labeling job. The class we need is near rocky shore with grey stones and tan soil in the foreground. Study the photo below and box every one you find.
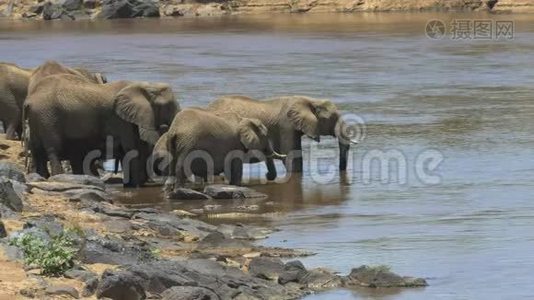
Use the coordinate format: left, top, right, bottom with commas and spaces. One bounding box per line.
0, 135, 427, 300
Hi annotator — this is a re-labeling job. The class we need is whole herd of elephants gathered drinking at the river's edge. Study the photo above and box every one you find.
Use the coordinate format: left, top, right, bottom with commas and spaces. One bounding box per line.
0, 61, 355, 191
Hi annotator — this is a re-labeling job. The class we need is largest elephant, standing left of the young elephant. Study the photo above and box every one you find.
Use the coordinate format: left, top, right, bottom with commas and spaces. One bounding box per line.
24, 74, 180, 187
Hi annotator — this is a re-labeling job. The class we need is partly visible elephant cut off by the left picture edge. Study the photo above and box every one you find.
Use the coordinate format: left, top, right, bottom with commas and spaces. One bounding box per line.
0, 63, 33, 140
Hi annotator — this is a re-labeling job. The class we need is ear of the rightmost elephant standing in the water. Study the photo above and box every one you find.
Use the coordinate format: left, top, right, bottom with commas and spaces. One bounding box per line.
287, 100, 319, 140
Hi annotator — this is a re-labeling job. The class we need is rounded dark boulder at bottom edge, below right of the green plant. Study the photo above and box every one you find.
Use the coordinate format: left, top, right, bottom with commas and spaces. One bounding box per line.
96, 270, 146, 300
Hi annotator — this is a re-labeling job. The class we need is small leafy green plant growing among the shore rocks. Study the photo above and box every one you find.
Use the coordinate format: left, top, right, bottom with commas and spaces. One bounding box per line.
11, 232, 77, 276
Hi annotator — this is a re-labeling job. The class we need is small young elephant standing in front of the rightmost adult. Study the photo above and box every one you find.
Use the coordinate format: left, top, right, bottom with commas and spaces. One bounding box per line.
155, 108, 285, 187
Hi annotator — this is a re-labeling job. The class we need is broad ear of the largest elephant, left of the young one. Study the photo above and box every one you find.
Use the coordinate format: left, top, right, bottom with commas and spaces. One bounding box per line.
114, 84, 159, 145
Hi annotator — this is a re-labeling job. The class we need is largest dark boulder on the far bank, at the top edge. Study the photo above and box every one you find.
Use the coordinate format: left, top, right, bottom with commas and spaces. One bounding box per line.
98, 0, 159, 19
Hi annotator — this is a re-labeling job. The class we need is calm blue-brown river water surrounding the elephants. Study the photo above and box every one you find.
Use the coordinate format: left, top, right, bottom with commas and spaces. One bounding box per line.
0, 13, 534, 299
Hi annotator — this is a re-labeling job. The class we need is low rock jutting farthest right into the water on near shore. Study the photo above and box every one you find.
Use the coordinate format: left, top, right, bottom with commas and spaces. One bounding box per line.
346, 265, 428, 288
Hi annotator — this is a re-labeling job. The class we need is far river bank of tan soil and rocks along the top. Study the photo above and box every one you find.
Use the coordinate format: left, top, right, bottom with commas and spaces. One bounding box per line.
0, 0, 534, 20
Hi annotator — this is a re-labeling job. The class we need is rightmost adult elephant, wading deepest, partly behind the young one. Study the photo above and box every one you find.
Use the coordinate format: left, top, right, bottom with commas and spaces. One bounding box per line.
208, 96, 356, 180
